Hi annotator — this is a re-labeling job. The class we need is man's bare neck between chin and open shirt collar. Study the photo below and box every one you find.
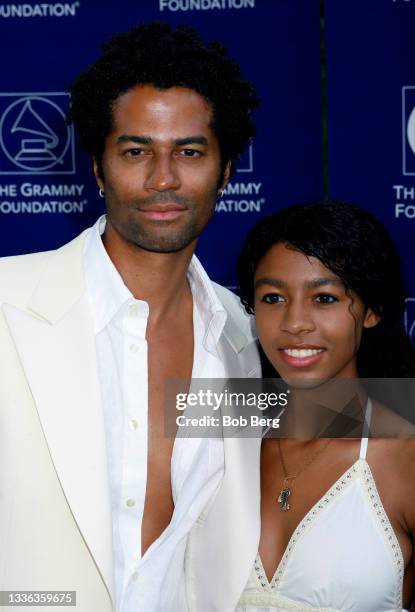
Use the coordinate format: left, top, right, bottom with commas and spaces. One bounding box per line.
102, 224, 196, 322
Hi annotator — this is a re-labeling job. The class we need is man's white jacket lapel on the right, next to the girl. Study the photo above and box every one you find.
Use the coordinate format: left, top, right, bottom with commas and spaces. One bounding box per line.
186, 316, 261, 612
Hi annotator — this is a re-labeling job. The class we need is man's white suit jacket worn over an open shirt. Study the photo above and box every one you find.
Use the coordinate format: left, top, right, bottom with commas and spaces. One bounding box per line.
0, 232, 259, 612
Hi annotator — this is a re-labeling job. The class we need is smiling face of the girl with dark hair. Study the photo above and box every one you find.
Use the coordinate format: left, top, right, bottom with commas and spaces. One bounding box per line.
254, 243, 379, 384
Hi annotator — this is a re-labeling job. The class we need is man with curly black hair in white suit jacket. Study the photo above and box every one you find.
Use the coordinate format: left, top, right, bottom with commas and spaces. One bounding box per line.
0, 23, 259, 612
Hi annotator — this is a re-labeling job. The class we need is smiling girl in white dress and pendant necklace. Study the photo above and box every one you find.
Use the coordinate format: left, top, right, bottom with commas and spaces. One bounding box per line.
237, 203, 415, 612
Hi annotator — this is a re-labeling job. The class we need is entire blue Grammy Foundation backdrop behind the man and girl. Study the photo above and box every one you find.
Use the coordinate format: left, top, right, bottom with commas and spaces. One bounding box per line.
0, 0, 415, 342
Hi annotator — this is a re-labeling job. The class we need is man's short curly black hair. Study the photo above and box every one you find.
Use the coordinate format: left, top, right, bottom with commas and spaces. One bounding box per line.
68, 22, 258, 179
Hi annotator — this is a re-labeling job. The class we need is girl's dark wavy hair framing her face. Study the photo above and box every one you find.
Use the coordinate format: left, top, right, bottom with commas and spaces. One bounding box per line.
237, 201, 415, 378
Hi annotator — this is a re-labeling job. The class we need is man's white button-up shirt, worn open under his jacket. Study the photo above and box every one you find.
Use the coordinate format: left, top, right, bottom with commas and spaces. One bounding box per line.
84, 215, 226, 612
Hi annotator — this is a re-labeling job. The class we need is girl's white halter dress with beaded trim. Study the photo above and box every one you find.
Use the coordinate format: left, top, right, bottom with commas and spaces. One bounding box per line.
235, 402, 404, 612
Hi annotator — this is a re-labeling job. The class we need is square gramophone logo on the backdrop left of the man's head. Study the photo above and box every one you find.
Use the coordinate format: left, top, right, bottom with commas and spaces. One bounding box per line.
0, 93, 75, 174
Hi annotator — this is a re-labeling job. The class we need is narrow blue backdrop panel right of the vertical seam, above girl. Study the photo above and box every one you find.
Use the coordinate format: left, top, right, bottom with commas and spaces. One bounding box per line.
325, 0, 415, 341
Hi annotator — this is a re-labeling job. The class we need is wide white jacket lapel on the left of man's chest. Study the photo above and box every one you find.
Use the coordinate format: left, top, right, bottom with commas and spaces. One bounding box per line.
3, 235, 113, 608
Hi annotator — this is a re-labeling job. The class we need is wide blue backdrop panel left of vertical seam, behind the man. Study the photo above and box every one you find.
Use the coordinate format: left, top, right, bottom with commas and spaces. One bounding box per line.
0, 0, 322, 286
